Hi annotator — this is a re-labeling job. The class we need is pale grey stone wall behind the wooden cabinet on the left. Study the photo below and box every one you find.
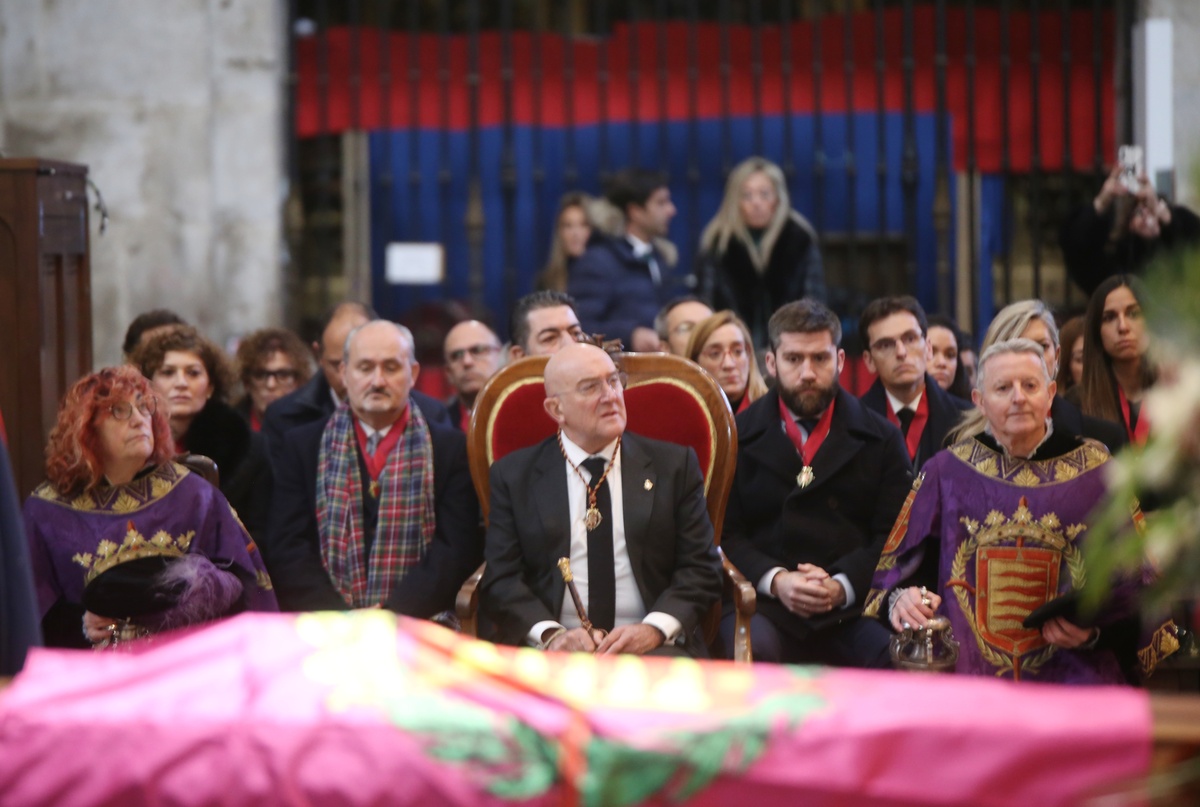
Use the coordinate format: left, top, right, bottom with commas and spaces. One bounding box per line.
0, 0, 286, 365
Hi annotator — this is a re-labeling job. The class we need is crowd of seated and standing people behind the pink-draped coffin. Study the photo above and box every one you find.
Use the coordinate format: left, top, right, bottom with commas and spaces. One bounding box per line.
2, 160, 1180, 682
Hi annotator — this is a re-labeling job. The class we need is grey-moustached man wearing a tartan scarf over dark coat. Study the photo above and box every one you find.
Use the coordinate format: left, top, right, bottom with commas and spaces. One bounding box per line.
268, 319, 484, 618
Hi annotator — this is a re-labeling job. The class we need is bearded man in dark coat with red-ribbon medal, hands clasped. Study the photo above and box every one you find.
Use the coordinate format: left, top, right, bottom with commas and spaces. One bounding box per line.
721, 299, 912, 666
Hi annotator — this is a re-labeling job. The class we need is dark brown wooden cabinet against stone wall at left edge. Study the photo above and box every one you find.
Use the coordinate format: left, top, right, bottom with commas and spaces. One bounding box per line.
0, 160, 91, 498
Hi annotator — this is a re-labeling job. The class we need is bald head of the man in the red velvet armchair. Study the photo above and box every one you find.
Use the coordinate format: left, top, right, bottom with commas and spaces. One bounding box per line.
545, 342, 625, 454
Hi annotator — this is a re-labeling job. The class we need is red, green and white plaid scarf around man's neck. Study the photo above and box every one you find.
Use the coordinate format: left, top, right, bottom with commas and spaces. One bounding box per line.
317, 402, 434, 608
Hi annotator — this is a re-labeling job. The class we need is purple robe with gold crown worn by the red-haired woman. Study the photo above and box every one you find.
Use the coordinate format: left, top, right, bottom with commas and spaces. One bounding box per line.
23, 462, 278, 616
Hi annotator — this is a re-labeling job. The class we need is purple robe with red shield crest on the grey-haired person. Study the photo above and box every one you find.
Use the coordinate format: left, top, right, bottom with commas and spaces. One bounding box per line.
865, 438, 1152, 683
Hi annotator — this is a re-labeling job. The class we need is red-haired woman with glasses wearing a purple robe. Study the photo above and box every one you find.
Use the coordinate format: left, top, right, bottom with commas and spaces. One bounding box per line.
24, 366, 277, 647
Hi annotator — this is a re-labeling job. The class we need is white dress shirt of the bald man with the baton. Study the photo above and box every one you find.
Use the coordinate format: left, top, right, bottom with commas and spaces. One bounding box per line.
527, 434, 683, 645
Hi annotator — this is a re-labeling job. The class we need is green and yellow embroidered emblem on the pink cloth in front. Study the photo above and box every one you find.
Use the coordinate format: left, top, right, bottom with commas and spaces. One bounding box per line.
296, 611, 827, 807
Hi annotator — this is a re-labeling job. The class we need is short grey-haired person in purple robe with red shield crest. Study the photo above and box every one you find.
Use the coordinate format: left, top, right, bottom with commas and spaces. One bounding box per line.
864, 339, 1177, 683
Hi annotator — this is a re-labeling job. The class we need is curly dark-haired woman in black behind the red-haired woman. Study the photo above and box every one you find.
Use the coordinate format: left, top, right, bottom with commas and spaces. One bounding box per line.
132, 327, 271, 542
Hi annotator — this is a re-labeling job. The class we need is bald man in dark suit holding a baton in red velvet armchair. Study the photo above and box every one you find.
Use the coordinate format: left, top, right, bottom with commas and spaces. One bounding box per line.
480, 343, 721, 657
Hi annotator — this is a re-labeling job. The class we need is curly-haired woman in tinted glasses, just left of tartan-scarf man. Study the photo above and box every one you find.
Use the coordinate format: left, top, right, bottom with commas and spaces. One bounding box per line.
234, 328, 312, 431
